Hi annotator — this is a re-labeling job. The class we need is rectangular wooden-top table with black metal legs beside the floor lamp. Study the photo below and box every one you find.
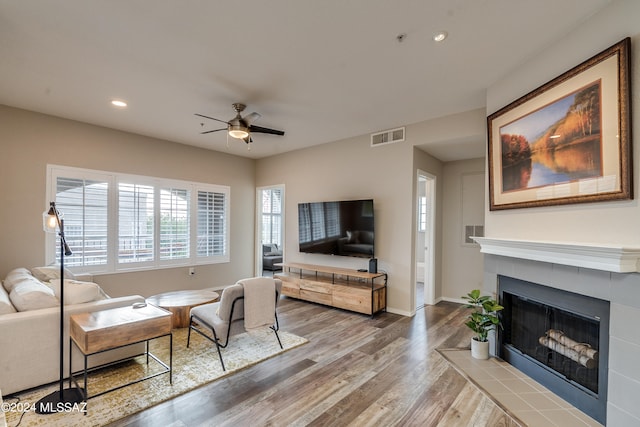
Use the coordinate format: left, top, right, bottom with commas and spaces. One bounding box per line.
69, 305, 173, 401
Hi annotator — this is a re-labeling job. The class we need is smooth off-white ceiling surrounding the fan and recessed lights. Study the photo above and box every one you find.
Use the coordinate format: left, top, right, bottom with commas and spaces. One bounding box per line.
0, 0, 610, 160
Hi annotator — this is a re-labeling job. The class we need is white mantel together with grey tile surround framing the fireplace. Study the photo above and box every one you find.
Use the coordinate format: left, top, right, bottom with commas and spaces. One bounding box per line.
475, 237, 640, 427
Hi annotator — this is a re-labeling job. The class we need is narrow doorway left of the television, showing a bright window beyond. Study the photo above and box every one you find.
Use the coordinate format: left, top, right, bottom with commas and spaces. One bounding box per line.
255, 185, 284, 276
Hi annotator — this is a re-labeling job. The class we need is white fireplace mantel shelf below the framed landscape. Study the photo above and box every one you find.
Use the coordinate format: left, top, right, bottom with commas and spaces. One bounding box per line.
473, 237, 640, 273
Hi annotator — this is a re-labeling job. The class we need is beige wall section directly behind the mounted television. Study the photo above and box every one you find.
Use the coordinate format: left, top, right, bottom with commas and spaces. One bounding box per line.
256, 135, 413, 314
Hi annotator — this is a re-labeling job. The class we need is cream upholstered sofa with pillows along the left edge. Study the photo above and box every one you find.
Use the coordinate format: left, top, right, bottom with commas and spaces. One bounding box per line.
0, 267, 144, 396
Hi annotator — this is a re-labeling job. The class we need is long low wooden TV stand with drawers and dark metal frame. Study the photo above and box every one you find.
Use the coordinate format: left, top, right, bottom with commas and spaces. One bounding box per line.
273, 262, 387, 317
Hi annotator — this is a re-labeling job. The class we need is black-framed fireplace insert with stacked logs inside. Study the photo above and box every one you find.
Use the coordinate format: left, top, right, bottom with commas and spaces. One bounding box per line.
498, 275, 609, 424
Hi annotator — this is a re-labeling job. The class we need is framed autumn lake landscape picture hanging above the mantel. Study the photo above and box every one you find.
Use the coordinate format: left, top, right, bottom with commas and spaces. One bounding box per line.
487, 38, 633, 210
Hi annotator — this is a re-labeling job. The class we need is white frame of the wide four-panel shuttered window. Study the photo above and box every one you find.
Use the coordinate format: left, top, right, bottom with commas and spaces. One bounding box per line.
45, 165, 231, 274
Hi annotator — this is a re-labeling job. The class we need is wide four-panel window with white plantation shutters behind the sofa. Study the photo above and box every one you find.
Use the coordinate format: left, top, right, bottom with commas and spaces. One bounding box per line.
46, 166, 230, 272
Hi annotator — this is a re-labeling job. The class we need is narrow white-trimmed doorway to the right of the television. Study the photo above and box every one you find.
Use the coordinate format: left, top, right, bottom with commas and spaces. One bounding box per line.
415, 170, 436, 310
